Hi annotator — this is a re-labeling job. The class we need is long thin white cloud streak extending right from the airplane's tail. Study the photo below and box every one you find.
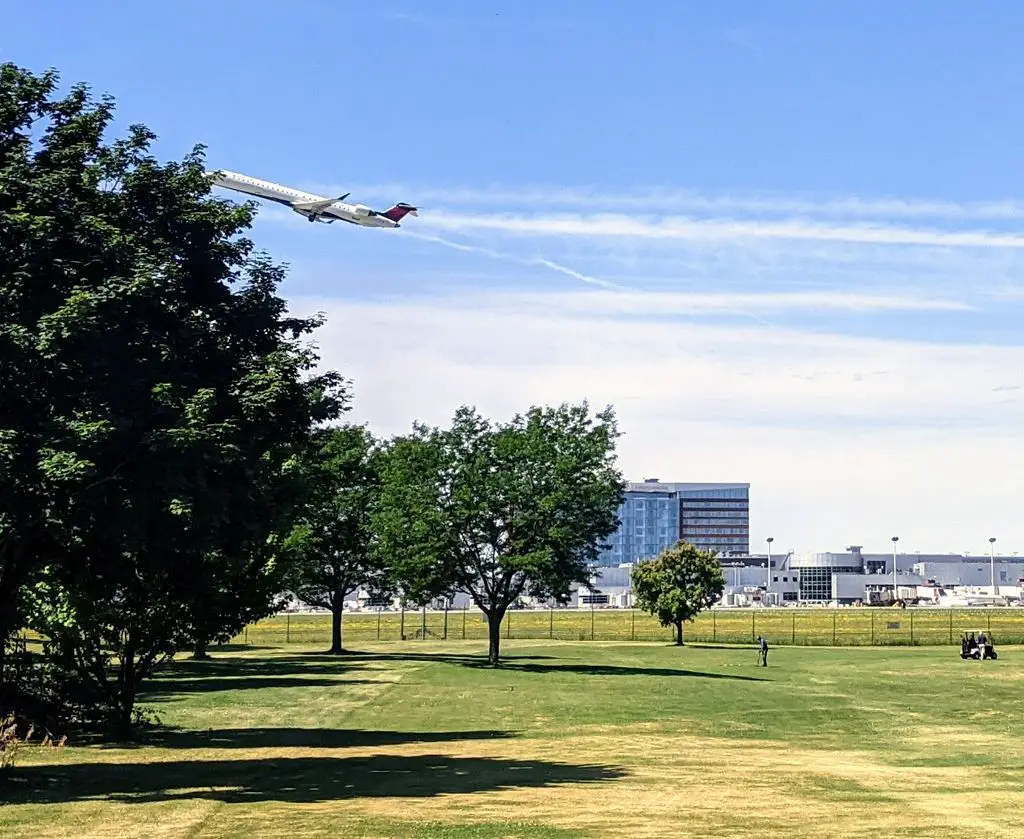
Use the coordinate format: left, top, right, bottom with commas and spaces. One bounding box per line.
424, 212, 1024, 249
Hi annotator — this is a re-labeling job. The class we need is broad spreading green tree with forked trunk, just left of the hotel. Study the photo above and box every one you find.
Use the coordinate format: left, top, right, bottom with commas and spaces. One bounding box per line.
373, 403, 625, 665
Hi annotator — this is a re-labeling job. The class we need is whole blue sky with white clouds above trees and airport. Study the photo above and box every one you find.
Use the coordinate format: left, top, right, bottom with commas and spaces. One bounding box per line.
8, 0, 1024, 551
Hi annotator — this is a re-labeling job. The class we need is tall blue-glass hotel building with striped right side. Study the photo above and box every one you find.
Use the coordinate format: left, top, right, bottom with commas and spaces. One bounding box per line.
598, 478, 751, 567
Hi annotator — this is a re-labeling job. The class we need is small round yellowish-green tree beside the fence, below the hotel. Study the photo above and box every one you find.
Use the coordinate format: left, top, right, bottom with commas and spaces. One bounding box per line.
632, 542, 725, 646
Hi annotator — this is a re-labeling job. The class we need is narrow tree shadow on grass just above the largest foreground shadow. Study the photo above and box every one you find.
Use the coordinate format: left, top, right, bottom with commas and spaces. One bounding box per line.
123, 728, 515, 749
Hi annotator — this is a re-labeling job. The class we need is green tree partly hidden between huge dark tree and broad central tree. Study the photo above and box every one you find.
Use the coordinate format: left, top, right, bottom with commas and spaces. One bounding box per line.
289, 425, 386, 655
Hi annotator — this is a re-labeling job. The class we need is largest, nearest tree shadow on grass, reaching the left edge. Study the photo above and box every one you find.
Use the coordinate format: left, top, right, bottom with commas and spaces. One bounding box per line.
4, 755, 626, 804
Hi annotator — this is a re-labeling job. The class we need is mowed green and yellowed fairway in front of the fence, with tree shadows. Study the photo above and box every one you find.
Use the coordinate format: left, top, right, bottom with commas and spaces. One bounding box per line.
0, 640, 1024, 839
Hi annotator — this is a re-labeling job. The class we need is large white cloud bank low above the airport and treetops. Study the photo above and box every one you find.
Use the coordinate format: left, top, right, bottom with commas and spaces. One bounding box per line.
294, 293, 1024, 551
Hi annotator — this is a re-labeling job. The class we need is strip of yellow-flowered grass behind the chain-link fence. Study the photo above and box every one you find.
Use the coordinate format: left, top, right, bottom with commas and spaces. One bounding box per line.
234, 607, 1024, 646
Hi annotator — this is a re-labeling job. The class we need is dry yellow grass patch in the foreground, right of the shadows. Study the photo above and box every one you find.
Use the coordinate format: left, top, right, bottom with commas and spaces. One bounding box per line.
337, 726, 1024, 839
